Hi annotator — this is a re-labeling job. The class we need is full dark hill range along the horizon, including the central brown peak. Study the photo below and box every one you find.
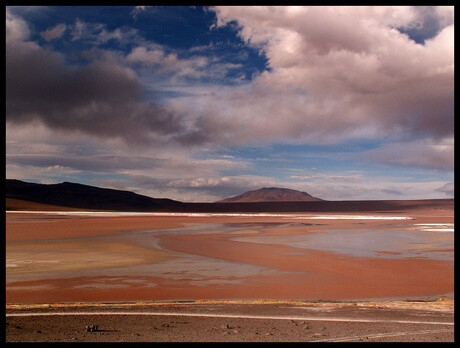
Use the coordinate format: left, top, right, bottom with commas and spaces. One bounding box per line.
5, 179, 454, 213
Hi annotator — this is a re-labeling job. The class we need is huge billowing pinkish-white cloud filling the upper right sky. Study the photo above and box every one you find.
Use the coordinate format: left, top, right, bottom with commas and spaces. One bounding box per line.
177, 7, 454, 144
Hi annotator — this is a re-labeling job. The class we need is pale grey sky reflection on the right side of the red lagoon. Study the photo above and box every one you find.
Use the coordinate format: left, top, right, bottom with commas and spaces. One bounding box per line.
130, 223, 454, 261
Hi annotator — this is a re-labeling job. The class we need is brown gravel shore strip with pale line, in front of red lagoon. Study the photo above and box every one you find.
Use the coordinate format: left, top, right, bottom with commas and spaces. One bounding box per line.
5, 300, 454, 342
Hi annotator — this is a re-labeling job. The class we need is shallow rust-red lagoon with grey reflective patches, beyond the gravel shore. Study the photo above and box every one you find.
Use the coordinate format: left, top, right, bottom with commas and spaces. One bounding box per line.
6, 214, 454, 301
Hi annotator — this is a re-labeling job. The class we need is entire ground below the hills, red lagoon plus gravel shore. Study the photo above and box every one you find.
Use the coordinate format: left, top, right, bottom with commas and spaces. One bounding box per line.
6, 205, 454, 341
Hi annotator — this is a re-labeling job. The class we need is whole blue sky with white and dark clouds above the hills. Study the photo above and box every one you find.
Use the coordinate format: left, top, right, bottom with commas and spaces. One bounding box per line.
5, 6, 454, 202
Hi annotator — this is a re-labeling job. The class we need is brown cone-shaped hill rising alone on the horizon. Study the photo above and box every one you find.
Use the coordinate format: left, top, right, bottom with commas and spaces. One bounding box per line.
217, 187, 322, 203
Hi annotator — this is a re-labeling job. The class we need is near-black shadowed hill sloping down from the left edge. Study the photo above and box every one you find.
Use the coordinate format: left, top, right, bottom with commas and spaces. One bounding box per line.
5, 179, 183, 211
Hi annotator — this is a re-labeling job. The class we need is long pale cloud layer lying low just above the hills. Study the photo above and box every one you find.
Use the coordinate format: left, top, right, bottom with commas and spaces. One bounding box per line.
6, 119, 451, 202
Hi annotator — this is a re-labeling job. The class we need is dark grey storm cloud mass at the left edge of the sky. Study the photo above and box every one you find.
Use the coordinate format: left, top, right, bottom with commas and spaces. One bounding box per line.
6, 31, 184, 143
